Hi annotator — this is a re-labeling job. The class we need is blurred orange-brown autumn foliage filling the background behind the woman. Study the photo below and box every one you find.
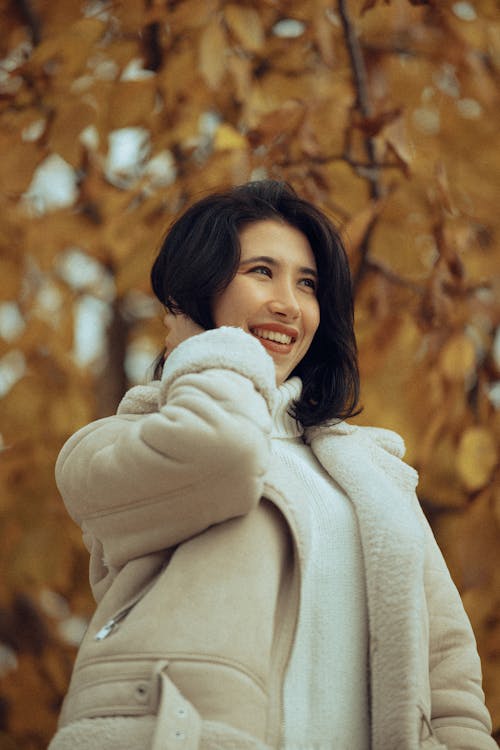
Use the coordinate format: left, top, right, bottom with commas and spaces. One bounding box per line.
0, 0, 500, 750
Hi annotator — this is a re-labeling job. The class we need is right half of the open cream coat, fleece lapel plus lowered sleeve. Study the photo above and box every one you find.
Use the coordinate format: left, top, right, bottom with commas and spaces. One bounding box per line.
310, 425, 495, 750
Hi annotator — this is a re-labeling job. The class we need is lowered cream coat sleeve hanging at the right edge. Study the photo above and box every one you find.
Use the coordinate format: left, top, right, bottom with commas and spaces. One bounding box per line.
420, 511, 497, 750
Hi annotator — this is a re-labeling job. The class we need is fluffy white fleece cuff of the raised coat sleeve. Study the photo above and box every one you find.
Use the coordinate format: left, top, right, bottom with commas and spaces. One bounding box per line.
160, 326, 277, 413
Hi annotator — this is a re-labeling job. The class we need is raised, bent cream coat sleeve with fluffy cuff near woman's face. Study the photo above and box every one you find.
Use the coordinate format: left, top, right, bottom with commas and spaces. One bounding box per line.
56, 328, 276, 576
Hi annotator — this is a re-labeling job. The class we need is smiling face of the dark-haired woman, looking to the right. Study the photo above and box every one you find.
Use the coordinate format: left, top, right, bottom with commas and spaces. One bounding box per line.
213, 219, 320, 385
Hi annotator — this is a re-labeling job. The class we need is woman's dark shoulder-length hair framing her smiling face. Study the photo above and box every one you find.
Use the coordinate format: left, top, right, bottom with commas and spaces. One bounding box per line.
151, 180, 359, 427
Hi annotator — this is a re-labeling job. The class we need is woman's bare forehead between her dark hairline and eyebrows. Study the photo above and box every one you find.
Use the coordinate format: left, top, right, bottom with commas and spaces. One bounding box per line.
239, 219, 316, 269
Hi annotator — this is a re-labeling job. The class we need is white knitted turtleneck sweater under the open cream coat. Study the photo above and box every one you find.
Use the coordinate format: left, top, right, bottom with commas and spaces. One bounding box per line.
272, 378, 370, 750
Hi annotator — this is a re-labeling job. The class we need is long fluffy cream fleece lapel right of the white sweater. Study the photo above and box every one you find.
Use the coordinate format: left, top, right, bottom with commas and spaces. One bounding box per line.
307, 422, 425, 748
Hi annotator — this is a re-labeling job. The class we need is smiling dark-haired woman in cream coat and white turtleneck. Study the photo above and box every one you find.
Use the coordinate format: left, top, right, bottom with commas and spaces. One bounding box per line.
51, 181, 496, 750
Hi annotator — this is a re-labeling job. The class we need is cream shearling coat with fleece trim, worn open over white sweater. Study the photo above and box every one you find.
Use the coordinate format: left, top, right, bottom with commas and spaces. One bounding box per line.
51, 328, 496, 750
